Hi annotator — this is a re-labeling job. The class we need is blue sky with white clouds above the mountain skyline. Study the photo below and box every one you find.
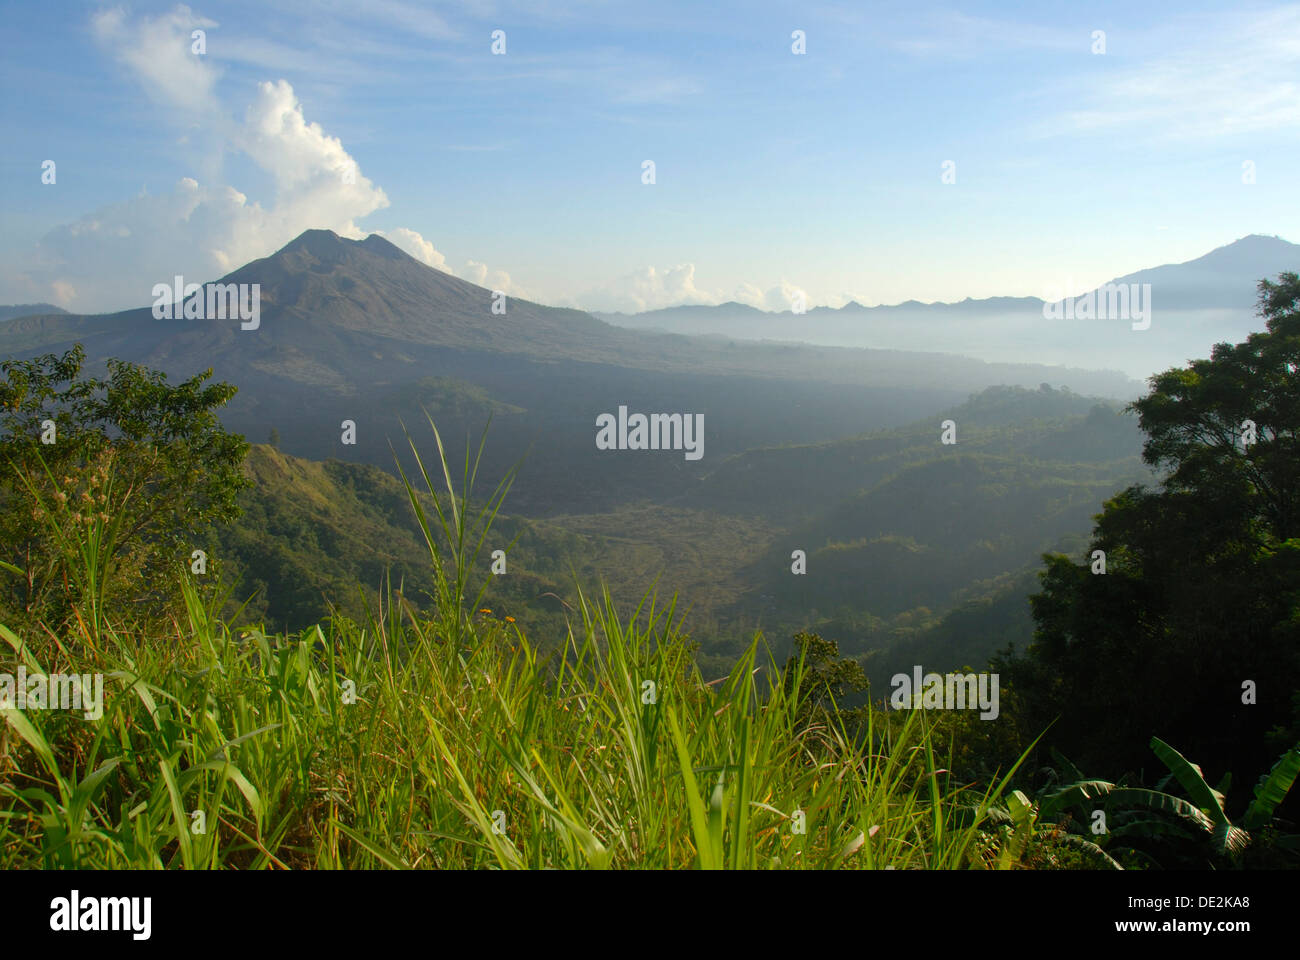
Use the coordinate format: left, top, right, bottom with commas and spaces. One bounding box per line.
0, 0, 1300, 311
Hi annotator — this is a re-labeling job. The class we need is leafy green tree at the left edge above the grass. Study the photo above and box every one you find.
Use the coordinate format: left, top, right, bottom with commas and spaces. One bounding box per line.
0, 343, 248, 626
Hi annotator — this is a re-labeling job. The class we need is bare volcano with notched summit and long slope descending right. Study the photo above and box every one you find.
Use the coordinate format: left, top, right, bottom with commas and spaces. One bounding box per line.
0, 230, 1139, 397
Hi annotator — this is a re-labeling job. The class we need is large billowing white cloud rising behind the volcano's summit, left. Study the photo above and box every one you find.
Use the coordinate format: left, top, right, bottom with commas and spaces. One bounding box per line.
5, 7, 403, 311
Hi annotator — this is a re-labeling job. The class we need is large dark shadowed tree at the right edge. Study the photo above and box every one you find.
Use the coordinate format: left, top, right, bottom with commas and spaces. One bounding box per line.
1010, 273, 1300, 784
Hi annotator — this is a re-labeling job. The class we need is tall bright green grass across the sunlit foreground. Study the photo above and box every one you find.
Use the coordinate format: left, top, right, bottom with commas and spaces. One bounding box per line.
0, 423, 1005, 869
